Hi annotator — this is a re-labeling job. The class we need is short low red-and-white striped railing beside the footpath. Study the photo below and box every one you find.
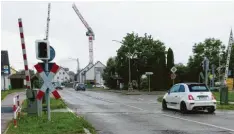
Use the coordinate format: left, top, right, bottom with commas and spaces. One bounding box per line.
13, 95, 21, 127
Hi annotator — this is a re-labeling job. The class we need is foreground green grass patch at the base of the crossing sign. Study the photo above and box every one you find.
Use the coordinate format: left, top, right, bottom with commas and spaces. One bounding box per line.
7, 112, 96, 134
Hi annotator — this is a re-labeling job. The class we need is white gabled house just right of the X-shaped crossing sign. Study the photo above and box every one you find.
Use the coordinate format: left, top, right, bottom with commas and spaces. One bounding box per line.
53, 67, 70, 83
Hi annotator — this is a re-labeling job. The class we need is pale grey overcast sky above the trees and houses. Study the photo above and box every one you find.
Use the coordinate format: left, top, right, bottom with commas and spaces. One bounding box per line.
1, 2, 234, 71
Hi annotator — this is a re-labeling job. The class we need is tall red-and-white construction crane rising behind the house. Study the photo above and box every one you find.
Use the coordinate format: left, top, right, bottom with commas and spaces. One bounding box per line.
72, 3, 95, 64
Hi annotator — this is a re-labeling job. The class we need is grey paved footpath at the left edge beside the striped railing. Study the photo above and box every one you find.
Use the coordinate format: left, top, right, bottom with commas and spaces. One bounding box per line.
1, 92, 26, 133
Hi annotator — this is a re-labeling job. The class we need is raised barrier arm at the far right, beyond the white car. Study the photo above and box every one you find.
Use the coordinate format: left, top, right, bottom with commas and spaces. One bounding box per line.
224, 30, 234, 83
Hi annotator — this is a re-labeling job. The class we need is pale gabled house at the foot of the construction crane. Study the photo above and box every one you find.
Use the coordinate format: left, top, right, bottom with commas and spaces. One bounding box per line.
78, 61, 106, 84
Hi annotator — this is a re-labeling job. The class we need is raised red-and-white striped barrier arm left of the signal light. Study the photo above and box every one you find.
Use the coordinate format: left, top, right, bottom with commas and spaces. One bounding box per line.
18, 18, 31, 89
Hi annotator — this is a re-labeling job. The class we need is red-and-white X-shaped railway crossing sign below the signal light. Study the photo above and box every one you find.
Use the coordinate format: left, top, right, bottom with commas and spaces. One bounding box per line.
34, 63, 60, 100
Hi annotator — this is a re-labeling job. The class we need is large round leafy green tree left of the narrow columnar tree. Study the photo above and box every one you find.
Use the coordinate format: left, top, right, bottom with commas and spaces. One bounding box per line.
116, 33, 166, 89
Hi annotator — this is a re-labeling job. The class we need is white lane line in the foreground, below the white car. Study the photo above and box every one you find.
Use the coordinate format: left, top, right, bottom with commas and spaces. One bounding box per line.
162, 114, 234, 132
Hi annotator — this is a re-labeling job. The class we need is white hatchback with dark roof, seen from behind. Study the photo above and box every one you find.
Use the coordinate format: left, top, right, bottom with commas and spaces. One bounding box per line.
162, 83, 216, 113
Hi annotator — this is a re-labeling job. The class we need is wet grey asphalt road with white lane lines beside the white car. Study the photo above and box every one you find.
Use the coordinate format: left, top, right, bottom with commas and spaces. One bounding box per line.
60, 88, 234, 134
